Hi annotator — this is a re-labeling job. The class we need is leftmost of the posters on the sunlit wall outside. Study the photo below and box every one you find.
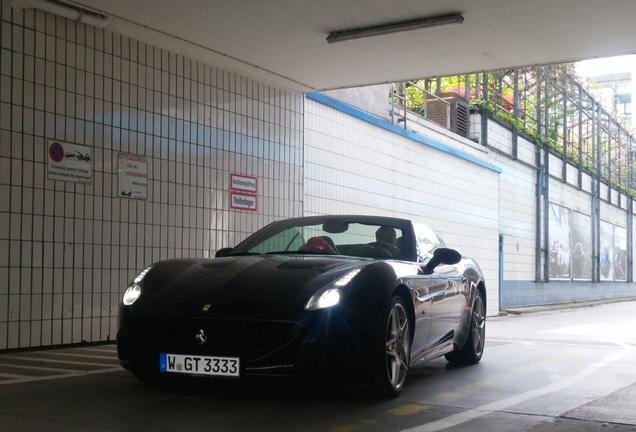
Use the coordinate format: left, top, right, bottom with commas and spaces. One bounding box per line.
550, 203, 570, 279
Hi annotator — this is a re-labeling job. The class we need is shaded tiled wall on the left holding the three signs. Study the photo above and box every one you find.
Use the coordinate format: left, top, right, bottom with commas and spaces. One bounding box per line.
0, 0, 304, 350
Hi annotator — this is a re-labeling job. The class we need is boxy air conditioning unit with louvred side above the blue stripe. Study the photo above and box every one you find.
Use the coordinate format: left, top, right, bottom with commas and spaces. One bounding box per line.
426, 93, 470, 138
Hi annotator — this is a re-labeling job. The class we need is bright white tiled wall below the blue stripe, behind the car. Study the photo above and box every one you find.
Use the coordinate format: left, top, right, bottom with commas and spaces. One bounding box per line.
305, 99, 500, 314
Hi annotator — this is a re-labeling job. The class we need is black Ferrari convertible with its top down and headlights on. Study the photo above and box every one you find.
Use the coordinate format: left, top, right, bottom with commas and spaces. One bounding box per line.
117, 216, 486, 397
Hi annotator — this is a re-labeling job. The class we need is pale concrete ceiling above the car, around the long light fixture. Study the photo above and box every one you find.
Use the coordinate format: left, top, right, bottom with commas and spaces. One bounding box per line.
67, 0, 636, 91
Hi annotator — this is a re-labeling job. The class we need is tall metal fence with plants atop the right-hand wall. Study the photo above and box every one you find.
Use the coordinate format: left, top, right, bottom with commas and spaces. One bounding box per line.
392, 64, 636, 197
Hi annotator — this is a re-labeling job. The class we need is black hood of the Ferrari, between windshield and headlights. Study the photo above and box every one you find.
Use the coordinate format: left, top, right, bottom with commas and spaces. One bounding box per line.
142, 255, 370, 316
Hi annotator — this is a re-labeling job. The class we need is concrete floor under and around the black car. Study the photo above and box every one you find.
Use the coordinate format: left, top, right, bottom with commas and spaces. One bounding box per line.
0, 302, 636, 432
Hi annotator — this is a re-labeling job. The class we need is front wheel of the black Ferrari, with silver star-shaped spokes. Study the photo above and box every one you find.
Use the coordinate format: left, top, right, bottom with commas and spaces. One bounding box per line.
373, 296, 411, 398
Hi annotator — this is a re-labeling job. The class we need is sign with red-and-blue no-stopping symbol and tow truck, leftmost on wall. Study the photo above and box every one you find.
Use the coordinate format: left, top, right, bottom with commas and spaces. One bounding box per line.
46, 141, 93, 184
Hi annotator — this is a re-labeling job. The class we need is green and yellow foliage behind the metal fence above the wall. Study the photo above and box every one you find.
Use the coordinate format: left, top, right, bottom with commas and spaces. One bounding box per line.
396, 64, 636, 197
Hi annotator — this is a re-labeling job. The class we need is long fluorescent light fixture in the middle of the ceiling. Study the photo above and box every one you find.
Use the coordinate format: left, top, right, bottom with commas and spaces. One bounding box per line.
327, 13, 464, 43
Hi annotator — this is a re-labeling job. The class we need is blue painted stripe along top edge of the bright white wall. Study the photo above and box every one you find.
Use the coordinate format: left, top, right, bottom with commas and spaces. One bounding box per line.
305, 93, 502, 174
